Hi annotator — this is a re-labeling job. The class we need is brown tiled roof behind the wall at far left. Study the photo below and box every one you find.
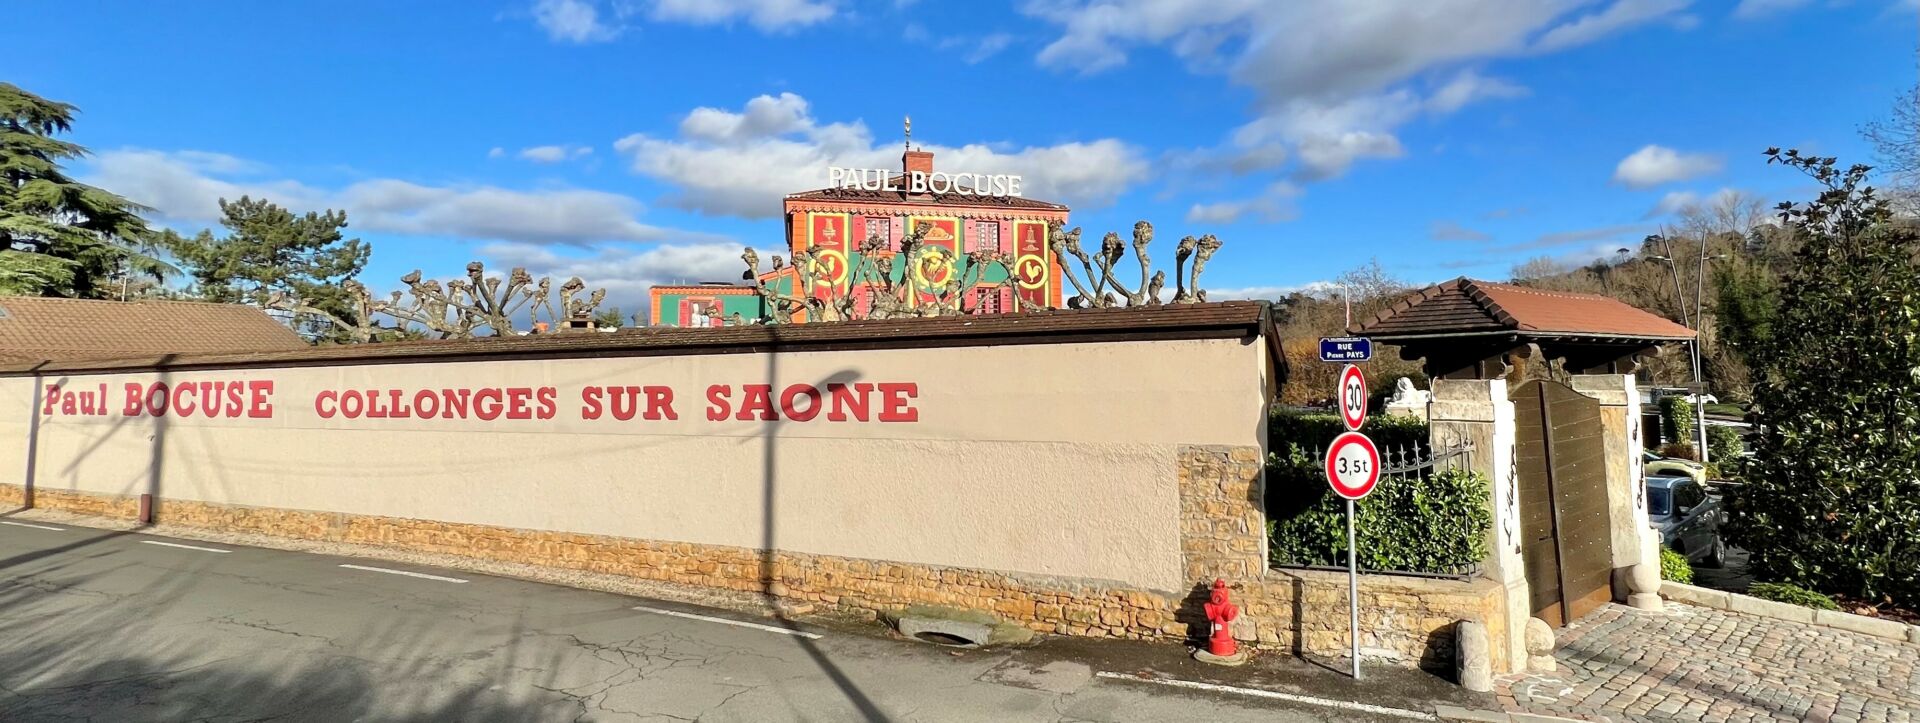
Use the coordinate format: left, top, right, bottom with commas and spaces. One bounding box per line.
0, 297, 307, 364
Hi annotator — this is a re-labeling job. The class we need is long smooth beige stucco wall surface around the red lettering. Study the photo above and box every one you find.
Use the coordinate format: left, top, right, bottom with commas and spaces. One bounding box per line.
0, 339, 1267, 589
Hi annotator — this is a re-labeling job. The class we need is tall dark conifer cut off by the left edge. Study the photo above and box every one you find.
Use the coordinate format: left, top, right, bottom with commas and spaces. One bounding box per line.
0, 82, 169, 297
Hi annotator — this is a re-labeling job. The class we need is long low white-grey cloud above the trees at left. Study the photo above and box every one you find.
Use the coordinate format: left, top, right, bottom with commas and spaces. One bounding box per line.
88, 150, 703, 244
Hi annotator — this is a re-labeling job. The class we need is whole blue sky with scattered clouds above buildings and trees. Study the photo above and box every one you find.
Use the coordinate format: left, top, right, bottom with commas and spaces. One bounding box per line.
0, 0, 1920, 311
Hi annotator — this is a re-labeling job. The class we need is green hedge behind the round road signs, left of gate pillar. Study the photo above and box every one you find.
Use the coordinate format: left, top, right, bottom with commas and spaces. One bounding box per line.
1267, 412, 1494, 573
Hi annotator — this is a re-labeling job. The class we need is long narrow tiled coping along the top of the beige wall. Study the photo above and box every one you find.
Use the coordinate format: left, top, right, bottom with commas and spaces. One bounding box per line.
0, 301, 1281, 376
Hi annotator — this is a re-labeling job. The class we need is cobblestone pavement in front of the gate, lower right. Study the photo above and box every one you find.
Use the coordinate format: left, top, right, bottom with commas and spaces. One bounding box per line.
1496, 602, 1920, 723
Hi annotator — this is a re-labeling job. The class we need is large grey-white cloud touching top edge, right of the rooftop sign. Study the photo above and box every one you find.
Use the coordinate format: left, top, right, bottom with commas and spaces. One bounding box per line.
1023, 0, 1690, 180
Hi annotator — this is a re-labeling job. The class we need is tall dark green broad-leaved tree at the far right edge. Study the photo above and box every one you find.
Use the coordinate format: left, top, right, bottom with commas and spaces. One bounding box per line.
1728, 150, 1920, 604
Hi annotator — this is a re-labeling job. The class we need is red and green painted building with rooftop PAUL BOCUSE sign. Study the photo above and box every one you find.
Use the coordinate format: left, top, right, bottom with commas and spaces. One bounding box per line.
649, 150, 1068, 326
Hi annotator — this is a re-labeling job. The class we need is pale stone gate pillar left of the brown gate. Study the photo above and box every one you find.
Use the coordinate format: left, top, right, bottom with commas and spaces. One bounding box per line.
1427, 378, 1532, 673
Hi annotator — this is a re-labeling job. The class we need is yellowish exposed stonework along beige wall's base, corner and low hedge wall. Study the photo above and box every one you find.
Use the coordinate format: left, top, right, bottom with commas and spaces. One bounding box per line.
0, 439, 1507, 669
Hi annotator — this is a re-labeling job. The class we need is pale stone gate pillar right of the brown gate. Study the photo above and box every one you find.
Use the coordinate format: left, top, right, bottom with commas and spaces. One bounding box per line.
1571, 374, 1661, 610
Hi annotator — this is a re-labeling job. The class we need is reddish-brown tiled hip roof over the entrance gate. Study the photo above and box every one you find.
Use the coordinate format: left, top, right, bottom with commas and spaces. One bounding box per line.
1352, 278, 1693, 341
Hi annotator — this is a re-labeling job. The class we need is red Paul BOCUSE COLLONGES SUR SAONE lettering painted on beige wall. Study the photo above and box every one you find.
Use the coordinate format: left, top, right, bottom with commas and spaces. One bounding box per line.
40, 380, 920, 422
